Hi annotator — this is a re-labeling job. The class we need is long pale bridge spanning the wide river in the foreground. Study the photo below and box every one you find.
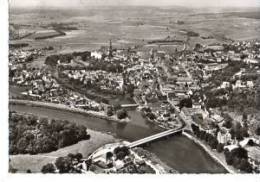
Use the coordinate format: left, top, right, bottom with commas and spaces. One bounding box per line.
127, 127, 183, 148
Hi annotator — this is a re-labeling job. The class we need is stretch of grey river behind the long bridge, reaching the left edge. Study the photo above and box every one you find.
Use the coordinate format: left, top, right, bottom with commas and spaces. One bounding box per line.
10, 105, 161, 141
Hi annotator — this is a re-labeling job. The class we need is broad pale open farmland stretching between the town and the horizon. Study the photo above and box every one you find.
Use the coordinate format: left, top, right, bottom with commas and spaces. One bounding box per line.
10, 7, 260, 53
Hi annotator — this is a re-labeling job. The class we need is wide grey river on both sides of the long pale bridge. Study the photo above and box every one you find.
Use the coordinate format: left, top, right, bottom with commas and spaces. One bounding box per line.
9, 105, 226, 173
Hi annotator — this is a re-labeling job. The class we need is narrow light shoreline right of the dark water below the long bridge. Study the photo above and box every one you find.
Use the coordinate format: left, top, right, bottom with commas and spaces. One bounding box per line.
182, 131, 237, 174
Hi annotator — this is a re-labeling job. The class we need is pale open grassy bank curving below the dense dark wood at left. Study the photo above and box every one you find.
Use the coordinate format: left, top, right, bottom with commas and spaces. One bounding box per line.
10, 129, 118, 173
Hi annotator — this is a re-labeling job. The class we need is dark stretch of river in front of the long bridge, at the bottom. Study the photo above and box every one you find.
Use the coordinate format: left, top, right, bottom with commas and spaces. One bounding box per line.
145, 135, 227, 173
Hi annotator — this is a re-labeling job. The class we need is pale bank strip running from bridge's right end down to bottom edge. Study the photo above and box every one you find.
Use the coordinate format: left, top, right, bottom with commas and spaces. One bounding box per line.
182, 131, 238, 174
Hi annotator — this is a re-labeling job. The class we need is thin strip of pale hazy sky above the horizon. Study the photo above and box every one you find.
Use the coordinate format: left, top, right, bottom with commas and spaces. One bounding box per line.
9, 0, 260, 7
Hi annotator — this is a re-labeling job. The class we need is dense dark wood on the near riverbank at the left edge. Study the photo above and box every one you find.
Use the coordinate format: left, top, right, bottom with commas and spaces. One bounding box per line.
9, 112, 90, 154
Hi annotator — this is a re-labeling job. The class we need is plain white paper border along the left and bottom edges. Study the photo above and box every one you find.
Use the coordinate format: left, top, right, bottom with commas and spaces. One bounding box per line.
0, 0, 260, 182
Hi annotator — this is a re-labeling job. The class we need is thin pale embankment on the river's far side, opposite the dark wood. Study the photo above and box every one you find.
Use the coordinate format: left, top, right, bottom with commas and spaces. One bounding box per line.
9, 99, 130, 123
